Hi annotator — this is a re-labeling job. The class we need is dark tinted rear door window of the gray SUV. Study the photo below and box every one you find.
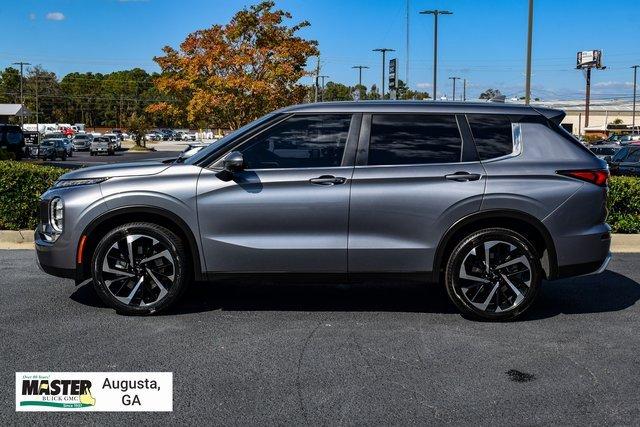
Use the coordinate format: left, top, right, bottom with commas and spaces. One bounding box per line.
369, 114, 462, 165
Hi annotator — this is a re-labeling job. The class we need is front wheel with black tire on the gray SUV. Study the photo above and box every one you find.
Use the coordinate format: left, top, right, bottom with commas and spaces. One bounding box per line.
91, 222, 189, 315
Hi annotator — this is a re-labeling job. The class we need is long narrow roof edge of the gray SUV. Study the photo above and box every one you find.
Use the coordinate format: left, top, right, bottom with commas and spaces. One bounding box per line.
279, 101, 546, 115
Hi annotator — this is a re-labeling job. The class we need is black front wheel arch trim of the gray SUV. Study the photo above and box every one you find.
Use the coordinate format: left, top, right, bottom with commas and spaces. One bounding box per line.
75, 205, 206, 283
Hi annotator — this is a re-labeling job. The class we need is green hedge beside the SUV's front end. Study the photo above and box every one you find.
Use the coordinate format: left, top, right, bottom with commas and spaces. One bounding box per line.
0, 161, 67, 230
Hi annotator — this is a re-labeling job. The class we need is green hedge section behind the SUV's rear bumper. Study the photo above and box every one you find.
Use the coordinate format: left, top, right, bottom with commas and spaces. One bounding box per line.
607, 176, 640, 233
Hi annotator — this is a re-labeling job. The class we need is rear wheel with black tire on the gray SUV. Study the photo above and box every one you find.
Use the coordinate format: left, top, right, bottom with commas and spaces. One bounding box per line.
445, 228, 543, 321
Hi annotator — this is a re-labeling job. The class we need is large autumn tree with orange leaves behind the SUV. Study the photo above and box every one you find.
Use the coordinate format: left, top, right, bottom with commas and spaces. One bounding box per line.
147, 1, 318, 129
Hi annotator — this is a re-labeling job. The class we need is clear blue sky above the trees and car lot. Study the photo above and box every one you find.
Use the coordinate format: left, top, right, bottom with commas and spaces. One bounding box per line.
0, 0, 640, 101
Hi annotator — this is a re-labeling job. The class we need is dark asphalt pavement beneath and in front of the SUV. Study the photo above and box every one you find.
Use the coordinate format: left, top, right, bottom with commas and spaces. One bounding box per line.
0, 251, 640, 425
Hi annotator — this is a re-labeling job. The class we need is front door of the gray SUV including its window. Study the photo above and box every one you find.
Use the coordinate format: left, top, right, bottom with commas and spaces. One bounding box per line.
197, 114, 357, 273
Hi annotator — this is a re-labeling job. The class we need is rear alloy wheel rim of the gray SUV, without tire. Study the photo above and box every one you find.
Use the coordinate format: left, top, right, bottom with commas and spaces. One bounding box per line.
457, 240, 532, 314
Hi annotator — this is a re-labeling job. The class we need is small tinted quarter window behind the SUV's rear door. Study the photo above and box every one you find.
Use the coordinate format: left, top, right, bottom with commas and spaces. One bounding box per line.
467, 114, 513, 160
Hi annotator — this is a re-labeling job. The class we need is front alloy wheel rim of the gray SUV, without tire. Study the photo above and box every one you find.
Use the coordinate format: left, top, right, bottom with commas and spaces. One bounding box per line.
99, 234, 176, 306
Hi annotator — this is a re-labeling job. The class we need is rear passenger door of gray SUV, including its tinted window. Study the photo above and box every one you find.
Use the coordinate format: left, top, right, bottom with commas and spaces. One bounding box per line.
349, 114, 485, 273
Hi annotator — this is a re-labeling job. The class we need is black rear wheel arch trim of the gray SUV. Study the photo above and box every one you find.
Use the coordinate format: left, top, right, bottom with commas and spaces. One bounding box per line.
433, 209, 558, 282
